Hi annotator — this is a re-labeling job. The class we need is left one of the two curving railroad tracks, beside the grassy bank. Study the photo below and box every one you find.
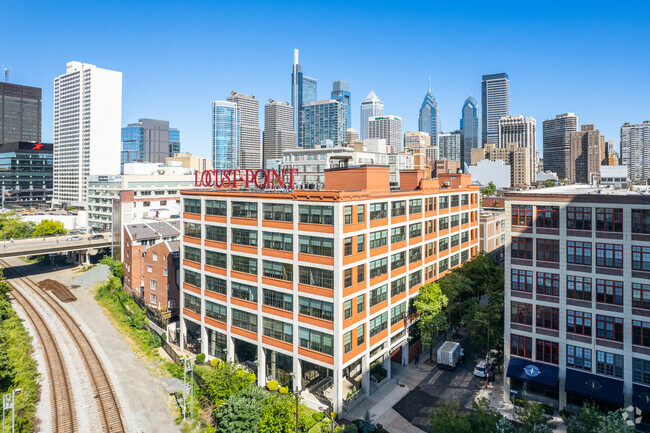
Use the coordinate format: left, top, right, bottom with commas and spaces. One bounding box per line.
12, 290, 77, 433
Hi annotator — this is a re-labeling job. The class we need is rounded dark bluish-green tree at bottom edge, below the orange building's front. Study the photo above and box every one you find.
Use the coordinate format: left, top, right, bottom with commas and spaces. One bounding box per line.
215, 386, 267, 433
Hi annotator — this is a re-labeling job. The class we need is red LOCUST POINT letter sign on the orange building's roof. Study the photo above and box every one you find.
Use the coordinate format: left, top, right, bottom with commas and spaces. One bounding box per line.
194, 168, 298, 189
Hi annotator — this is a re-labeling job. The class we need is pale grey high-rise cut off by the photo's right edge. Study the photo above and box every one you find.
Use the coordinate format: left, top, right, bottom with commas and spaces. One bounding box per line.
621, 120, 650, 181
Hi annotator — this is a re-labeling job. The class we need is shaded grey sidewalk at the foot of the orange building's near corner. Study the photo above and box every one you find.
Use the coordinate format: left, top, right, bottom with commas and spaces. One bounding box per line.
341, 362, 434, 433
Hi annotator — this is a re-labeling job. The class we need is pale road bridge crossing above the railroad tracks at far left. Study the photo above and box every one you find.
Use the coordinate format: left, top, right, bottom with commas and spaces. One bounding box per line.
0, 233, 112, 259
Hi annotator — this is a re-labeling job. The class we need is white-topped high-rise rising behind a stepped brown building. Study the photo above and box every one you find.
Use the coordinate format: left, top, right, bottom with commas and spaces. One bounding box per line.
497, 115, 537, 185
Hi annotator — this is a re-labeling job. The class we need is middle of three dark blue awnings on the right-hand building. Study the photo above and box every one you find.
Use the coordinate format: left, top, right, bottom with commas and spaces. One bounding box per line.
564, 368, 623, 406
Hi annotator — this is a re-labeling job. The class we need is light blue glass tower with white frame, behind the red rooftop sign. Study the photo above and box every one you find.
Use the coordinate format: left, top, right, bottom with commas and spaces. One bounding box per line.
212, 101, 241, 170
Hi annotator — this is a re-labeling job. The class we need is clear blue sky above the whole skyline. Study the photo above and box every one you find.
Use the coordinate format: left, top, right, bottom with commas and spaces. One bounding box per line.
0, 0, 650, 156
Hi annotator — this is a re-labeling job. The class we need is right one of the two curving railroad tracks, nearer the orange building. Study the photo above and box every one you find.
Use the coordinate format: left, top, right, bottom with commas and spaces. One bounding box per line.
0, 260, 126, 433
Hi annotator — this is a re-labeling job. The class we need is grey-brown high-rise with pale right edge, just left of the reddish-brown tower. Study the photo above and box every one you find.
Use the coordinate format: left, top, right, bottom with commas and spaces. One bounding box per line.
542, 113, 578, 179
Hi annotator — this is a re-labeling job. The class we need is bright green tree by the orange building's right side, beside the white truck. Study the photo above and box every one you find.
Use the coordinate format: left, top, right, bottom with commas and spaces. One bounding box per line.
414, 283, 449, 358
